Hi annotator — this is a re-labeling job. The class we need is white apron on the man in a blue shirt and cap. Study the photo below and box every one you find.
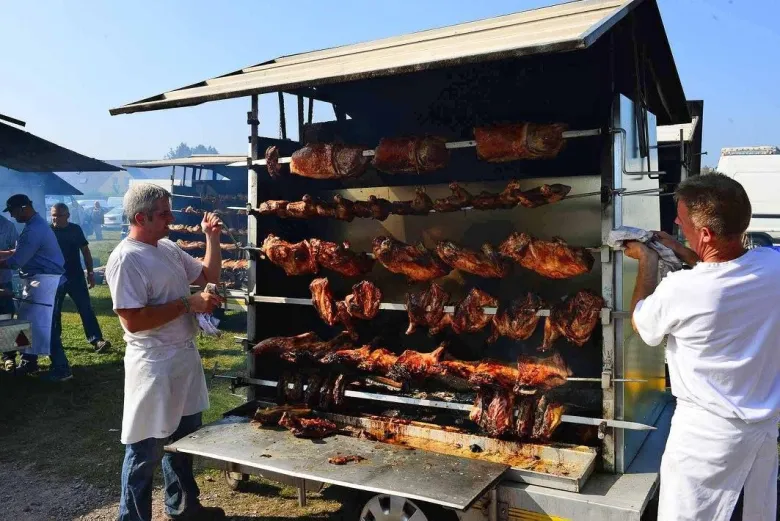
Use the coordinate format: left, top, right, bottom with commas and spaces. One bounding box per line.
17, 275, 62, 356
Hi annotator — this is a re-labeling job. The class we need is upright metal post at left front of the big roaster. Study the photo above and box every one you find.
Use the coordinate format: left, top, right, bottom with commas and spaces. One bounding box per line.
246, 94, 260, 401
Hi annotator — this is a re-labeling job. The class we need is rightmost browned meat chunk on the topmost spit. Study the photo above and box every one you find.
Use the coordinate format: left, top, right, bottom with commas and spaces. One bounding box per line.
474, 123, 566, 163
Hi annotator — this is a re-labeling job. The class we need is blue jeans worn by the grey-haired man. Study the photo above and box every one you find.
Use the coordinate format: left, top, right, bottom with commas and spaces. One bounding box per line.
118, 413, 203, 521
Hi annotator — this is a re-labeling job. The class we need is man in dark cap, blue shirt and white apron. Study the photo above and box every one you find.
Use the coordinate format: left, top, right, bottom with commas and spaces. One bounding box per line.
0, 194, 73, 381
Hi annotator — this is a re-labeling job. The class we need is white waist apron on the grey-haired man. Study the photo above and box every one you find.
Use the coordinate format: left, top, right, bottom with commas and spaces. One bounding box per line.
121, 341, 209, 444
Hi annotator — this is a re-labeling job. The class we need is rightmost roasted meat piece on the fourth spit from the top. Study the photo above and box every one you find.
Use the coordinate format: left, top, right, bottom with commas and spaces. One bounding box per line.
540, 290, 606, 351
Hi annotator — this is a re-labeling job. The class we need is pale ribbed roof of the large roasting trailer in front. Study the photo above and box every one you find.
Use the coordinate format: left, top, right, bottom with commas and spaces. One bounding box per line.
110, 0, 644, 115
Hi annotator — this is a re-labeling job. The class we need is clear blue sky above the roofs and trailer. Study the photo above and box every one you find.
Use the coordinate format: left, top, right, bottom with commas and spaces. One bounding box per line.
0, 0, 780, 164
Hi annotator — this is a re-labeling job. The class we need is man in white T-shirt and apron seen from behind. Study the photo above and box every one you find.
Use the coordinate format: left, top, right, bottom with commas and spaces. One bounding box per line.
625, 174, 780, 521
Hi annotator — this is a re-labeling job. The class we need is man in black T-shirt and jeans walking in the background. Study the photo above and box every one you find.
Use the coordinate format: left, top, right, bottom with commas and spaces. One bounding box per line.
51, 203, 111, 353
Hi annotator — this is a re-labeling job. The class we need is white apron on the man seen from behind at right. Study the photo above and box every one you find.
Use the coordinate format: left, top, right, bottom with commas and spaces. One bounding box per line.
658, 399, 778, 521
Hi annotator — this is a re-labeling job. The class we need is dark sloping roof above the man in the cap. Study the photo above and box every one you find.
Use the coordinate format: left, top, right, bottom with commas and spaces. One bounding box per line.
0, 123, 121, 172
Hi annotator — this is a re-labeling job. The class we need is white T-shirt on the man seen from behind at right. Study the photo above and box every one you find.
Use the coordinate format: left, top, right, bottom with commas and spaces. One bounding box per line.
634, 248, 780, 423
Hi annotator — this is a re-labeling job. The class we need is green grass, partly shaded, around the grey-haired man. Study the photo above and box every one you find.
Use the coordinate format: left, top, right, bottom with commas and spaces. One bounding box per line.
0, 232, 246, 496
